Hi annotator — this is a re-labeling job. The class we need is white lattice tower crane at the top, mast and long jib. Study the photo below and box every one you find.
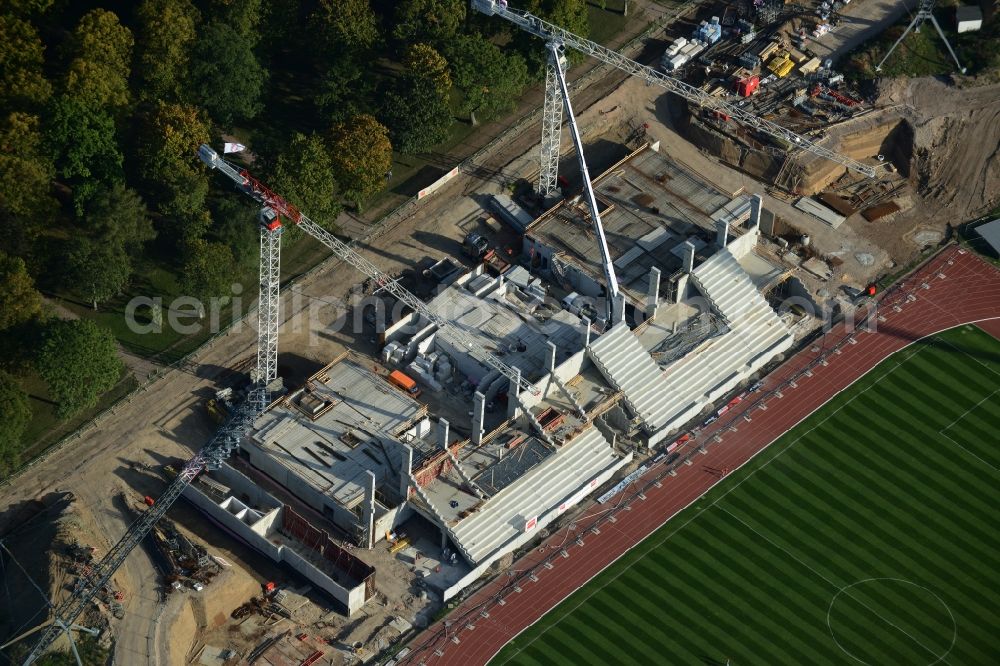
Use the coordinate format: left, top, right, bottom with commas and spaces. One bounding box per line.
470, 0, 876, 196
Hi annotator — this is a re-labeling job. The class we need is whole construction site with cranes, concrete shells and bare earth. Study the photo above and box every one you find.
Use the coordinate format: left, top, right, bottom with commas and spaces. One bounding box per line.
0, 0, 1000, 666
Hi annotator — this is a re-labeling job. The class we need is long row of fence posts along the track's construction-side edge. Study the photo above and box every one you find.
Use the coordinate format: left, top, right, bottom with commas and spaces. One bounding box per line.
397, 244, 962, 666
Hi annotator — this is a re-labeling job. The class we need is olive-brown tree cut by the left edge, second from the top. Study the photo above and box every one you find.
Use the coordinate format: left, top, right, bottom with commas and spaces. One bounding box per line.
0, 111, 56, 221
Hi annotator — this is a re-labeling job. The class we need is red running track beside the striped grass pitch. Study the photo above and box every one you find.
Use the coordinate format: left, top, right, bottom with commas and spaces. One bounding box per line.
399, 246, 1000, 666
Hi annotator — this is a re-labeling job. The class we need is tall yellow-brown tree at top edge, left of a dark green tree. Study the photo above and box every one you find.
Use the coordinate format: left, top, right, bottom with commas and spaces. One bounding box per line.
136, 0, 200, 100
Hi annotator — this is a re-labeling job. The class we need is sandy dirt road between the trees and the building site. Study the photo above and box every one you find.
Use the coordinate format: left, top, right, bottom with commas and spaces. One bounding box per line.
0, 0, 688, 663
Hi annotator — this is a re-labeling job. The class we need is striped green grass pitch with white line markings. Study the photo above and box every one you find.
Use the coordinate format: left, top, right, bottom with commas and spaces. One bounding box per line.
491, 326, 1000, 666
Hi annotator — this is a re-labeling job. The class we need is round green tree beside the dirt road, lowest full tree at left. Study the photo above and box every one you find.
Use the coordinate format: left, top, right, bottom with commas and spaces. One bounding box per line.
35, 319, 125, 418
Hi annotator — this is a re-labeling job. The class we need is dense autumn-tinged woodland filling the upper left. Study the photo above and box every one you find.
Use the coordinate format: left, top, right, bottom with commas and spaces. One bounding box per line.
0, 0, 587, 474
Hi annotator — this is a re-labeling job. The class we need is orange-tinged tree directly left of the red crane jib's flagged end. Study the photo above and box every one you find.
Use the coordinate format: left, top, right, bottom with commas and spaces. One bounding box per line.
136, 102, 210, 217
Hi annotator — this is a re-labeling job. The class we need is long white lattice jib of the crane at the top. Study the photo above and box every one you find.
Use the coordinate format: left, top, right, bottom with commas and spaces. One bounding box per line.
471, 0, 876, 179
